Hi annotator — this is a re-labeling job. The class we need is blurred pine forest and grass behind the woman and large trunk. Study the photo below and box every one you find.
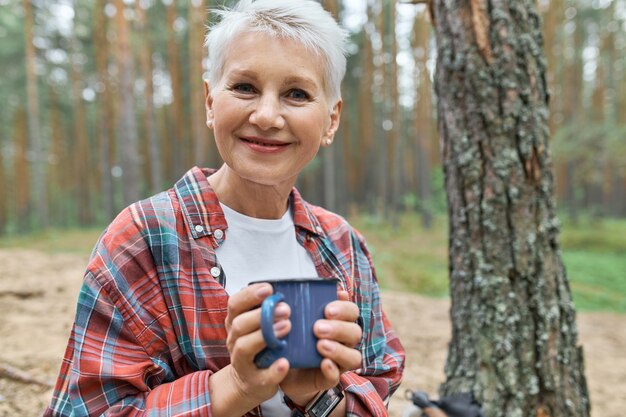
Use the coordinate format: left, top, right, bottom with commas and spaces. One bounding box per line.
0, 0, 626, 312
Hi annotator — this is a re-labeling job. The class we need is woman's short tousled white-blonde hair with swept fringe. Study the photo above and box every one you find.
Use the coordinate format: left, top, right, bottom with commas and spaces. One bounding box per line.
205, 0, 347, 105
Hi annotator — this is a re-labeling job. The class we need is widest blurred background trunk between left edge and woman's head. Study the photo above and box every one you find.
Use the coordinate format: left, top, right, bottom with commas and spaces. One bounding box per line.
115, 0, 140, 204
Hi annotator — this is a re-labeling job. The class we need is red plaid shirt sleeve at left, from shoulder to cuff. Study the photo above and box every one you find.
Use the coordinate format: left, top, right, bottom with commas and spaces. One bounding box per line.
44, 208, 227, 417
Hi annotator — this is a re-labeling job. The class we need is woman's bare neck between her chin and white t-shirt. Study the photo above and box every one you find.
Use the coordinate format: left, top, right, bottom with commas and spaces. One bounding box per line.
208, 164, 295, 219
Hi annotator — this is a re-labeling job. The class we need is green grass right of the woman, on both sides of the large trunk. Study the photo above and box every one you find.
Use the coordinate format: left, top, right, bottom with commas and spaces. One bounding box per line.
351, 211, 626, 314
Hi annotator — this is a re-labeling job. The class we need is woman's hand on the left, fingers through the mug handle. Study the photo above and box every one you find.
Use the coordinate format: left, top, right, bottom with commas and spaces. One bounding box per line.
226, 284, 291, 404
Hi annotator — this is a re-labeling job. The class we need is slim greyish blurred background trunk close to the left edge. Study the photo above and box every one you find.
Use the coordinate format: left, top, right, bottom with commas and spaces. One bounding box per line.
23, 0, 48, 228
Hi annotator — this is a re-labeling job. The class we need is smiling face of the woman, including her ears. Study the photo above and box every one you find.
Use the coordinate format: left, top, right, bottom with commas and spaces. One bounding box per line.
206, 33, 341, 185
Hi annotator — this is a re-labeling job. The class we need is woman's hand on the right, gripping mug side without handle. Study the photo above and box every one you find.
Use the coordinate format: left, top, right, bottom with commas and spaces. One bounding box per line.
280, 291, 362, 405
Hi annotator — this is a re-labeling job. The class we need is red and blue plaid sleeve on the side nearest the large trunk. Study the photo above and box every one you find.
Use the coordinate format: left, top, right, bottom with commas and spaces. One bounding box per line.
340, 232, 405, 417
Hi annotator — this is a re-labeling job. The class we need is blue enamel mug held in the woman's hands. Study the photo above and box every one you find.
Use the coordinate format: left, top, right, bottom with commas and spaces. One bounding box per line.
251, 278, 339, 368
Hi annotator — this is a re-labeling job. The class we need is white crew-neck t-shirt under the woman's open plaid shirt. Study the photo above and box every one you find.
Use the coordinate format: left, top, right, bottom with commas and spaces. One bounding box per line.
215, 203, 317, 417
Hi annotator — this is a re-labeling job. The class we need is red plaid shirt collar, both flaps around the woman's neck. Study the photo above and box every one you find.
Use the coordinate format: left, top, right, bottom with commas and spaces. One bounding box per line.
174, 167, 325, 239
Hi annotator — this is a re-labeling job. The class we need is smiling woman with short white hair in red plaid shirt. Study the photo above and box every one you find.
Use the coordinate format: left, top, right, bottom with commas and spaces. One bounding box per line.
45, 0, 404, 416
